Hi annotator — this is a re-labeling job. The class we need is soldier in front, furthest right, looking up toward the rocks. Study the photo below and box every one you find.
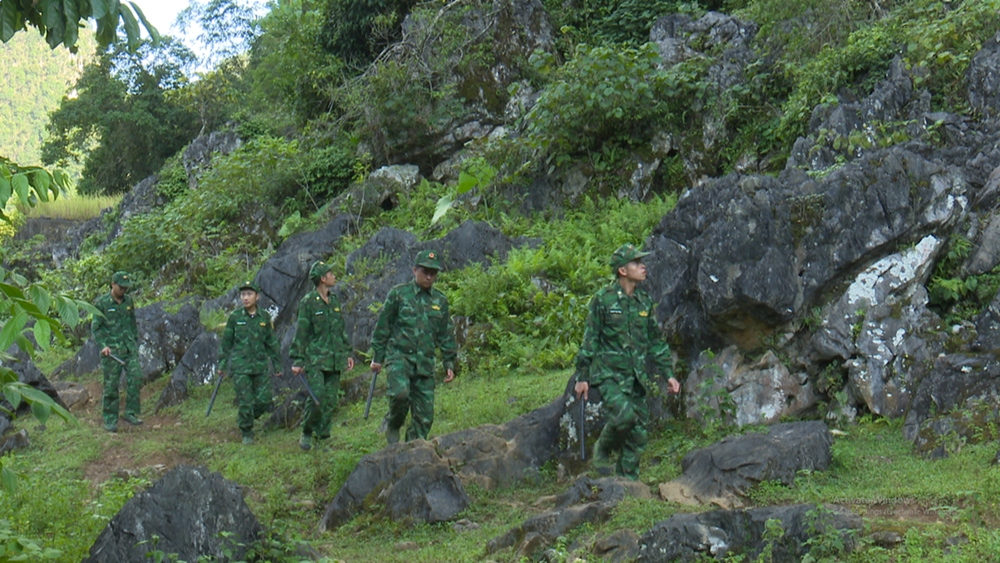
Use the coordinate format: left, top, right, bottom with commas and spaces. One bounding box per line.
575, 244, 680, 480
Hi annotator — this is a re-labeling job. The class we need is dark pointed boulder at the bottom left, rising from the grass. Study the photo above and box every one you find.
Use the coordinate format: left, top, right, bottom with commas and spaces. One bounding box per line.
84, 465, 263, 563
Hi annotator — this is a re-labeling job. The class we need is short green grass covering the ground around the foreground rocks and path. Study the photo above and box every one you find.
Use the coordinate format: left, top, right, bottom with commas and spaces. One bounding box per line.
0, 364, 1000, 561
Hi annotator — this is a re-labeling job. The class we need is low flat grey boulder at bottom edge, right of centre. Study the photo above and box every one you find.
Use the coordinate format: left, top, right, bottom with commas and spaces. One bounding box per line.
638, 504, 863, 563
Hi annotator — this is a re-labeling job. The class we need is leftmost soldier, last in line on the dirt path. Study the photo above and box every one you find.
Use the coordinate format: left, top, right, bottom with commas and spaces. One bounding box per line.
90, 272, 142, 432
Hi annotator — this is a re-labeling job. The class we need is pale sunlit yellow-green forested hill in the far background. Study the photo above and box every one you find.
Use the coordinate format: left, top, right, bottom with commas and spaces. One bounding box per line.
0, 30, 94, 164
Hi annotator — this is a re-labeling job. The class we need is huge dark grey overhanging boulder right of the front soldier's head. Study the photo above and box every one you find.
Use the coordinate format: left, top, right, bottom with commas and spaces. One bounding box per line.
646, 146, 966, 355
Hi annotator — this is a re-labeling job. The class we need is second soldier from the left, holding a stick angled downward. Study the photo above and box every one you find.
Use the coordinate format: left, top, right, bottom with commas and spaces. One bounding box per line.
219, 281, 281, 446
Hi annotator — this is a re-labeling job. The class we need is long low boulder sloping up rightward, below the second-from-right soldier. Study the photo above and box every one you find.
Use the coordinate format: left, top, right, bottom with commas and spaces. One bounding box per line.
319, 398, 563, 530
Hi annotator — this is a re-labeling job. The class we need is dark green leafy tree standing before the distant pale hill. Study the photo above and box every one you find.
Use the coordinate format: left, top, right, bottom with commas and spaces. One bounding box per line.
42, 37, 198, 195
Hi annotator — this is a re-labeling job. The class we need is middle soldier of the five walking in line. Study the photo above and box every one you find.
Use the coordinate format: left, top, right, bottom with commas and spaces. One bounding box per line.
289, 262, 354, 450
